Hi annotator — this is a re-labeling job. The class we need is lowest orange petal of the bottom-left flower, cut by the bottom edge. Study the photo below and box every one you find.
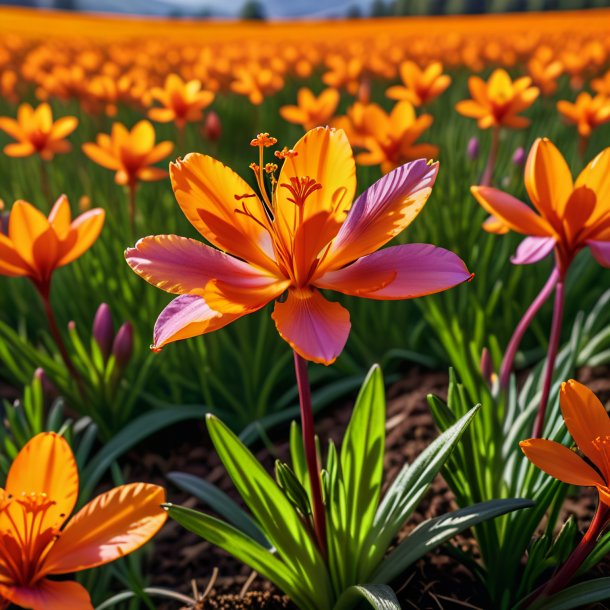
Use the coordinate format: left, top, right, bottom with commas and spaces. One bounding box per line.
0, 579, 93, 610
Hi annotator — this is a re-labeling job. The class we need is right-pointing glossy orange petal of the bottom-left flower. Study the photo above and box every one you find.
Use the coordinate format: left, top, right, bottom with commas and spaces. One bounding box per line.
42, 483, 167, 574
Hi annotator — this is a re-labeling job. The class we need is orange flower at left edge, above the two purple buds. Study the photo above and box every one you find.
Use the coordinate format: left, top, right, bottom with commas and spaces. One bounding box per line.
0, 195, 105, 291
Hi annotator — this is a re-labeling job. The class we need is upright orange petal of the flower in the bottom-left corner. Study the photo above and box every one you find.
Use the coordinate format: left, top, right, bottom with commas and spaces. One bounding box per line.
6, 432, 78, 527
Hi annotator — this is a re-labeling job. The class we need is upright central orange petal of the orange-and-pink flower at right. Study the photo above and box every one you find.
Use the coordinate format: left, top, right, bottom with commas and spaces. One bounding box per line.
525, 138, 574, 222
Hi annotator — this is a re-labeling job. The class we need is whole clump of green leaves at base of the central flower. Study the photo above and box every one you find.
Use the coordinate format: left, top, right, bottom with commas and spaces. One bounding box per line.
167, 367, 532, 610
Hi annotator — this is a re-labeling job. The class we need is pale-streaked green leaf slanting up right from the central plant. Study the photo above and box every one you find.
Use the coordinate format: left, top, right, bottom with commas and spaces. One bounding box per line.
359, 405, 480, 580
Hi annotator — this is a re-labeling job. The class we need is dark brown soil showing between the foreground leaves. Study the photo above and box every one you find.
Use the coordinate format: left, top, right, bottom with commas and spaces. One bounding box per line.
113, 369, 610, 610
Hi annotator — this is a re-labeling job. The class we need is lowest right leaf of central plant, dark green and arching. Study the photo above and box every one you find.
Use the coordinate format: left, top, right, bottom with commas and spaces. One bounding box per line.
373, 498, 534, 582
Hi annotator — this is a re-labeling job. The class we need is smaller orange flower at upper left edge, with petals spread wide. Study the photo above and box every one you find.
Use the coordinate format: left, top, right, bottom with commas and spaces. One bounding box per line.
0, 103, 78, 161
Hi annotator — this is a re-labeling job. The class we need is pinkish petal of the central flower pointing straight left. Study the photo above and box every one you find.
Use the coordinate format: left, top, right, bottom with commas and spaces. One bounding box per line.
125, 235, 276, 294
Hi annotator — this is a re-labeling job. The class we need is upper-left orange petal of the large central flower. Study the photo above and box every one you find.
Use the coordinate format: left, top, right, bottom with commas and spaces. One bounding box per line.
170, 153, 276, 269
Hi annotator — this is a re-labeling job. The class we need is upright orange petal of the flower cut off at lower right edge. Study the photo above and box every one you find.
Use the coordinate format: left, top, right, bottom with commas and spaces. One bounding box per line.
559, 379, 610, 481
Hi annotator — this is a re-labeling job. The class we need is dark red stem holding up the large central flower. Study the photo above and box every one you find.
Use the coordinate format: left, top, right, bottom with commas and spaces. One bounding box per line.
294, 352, 326, 556
